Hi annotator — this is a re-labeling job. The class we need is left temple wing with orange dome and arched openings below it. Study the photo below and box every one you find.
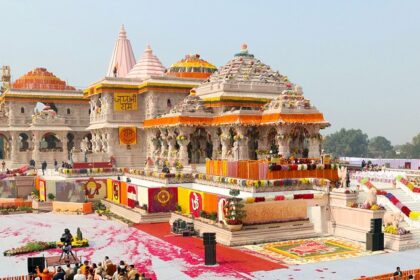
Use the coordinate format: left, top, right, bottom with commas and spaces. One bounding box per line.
0, 68, 89, 166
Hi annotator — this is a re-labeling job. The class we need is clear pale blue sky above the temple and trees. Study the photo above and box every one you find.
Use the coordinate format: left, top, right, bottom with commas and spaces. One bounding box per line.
0, 0, 420, 144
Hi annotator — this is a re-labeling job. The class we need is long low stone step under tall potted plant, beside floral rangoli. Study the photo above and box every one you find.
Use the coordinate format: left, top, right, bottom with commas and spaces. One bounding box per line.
169, 213, 319, 246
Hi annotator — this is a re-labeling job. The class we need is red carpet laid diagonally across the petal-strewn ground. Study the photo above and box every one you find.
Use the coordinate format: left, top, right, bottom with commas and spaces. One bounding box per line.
135, 223, 287, 273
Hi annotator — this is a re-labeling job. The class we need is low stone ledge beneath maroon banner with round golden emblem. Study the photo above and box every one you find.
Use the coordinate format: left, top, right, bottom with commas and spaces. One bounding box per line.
101, 199, 171, 224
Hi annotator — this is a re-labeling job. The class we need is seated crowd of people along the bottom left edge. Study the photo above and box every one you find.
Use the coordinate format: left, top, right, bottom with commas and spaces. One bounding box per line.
35, 257, 150, 280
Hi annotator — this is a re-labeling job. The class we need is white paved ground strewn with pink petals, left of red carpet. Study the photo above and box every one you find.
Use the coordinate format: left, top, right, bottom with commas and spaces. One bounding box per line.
0, 213, 249, 279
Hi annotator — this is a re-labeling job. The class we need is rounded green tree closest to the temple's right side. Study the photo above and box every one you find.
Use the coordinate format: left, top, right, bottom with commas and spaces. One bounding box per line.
323, 128, 368, 157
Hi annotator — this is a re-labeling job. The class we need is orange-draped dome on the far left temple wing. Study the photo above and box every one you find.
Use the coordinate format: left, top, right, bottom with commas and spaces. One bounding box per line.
12, 68, 76, 90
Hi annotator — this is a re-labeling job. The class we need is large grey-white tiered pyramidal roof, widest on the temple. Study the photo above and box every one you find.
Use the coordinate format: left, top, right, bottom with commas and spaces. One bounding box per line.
203, 44, 293, 88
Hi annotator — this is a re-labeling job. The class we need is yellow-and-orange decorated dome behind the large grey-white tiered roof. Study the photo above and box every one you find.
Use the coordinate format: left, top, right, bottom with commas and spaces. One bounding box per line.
167, 54, 217, 79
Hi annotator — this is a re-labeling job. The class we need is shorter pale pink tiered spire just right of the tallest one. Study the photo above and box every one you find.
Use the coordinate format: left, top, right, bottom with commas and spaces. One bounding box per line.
126, 46, 165, 79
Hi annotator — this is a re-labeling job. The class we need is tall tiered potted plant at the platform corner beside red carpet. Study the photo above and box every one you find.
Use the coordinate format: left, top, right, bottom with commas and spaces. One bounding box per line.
225, 190, 246, 231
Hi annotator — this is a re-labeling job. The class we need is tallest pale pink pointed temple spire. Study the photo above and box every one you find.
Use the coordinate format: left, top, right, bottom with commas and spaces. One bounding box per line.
106, 25, 136, 77
